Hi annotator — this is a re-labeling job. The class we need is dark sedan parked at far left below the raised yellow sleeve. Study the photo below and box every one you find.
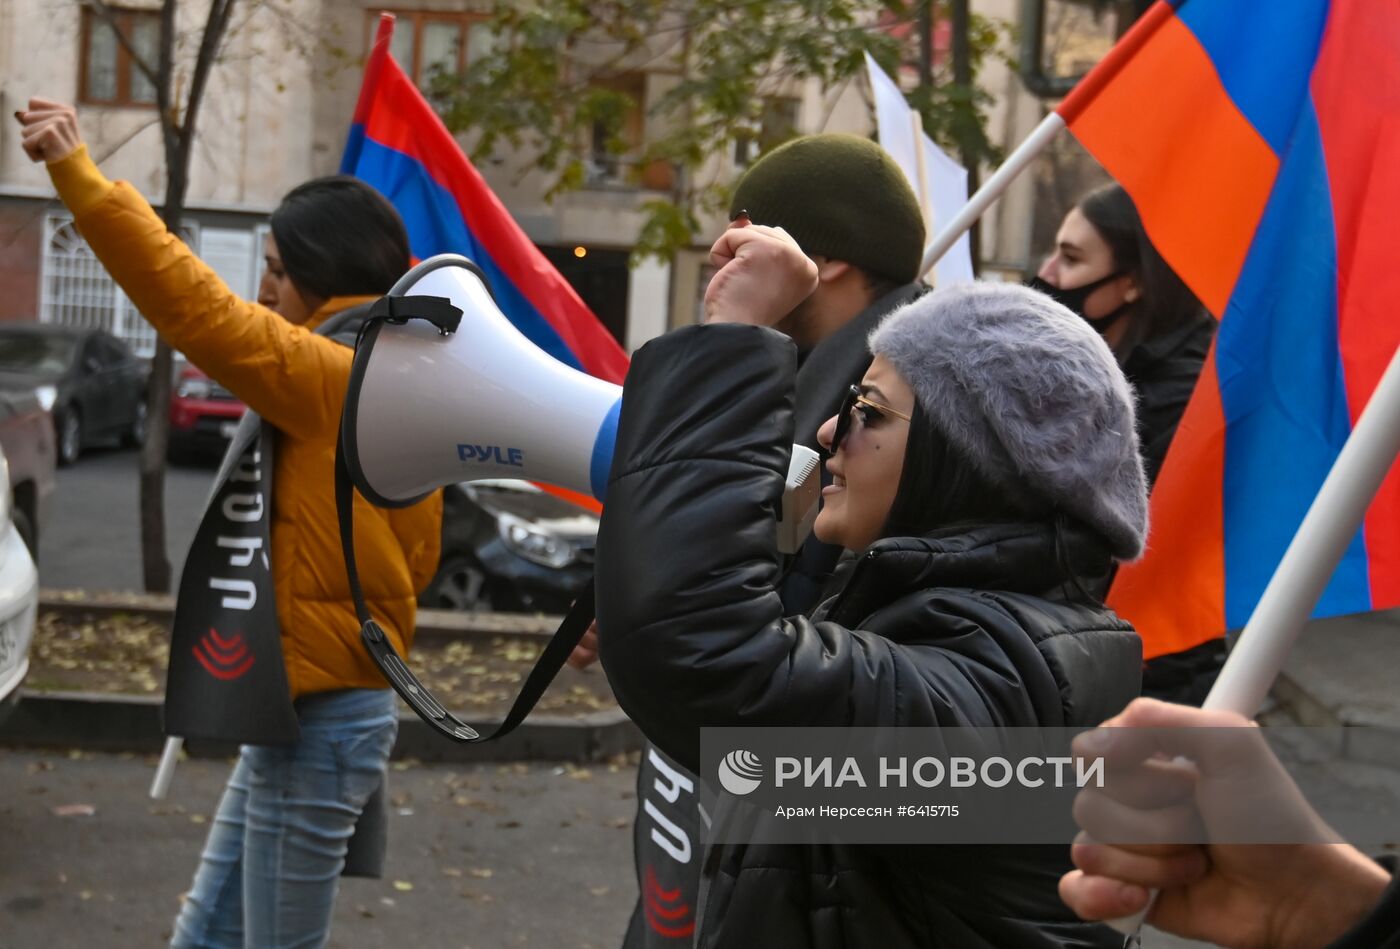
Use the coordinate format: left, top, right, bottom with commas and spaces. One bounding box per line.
0, 323, 148, 465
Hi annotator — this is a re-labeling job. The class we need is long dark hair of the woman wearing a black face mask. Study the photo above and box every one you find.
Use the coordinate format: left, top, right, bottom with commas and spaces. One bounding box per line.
1079, 185, 1207, 354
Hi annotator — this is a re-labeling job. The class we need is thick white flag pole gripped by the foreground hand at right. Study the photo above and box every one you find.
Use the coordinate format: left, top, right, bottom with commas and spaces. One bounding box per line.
1204, 349, 1400, 718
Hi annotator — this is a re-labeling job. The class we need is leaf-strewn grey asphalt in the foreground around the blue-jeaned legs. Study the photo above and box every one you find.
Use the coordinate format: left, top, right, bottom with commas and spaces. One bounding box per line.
0, 750, 637, 949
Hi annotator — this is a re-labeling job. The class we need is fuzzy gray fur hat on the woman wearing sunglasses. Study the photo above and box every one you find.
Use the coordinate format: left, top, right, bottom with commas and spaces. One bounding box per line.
869, 283, 1147, 560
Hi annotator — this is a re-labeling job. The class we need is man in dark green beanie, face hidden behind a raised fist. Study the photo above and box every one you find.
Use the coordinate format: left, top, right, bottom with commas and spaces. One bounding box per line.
623, 134, 924, 949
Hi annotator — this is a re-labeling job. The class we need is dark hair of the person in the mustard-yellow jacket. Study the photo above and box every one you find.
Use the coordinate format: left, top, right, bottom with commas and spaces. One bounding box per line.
272, 175, 409, 300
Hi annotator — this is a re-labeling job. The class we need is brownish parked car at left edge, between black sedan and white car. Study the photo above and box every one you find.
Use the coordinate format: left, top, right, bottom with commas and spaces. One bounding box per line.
0, 389, 57, 560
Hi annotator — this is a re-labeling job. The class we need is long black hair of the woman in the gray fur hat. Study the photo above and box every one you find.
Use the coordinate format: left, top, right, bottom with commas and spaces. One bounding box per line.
881, 398, 1107, 602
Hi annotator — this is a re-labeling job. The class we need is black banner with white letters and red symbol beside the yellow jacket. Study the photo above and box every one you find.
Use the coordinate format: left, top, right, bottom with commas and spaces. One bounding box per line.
165, 412, 300, 745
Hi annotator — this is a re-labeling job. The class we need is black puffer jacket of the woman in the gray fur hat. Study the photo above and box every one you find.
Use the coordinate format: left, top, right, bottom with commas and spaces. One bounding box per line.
598, 326, 1141, 949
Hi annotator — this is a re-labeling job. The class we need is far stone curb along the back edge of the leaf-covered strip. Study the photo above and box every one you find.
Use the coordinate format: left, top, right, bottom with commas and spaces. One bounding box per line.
39, 589, 563, 642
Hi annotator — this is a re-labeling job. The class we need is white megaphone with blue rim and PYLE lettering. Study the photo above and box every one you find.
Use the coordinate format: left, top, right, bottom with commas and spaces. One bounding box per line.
342, 253, 820, 553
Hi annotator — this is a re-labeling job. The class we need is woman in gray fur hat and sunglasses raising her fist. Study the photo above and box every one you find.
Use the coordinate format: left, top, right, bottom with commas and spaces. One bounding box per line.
596, 225, 1147, 949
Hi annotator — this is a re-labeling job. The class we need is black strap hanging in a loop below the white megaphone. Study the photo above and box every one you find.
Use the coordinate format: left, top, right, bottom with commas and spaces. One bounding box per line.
336, 435, 594, 743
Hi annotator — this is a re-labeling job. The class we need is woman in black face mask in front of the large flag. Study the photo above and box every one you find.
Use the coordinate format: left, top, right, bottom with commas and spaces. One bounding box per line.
1030, 185, 1225, 705
